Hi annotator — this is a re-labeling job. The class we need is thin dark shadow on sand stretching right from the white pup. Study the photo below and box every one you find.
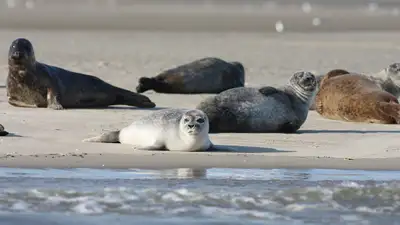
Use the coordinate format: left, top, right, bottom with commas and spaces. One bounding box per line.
207, 145, 295, 153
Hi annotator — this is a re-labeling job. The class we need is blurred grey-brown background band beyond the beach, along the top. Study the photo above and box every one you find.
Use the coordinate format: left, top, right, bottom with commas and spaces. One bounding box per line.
0, 0, 400, 32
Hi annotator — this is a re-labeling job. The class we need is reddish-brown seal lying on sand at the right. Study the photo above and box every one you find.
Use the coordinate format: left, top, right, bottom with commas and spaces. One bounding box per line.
315, 70, 400, 124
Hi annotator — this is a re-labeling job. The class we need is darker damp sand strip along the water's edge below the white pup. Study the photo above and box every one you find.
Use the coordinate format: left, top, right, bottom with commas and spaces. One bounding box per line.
0, 152, 400, 171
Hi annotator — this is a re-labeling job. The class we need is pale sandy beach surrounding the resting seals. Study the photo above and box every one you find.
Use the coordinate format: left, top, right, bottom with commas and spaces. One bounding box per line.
0, 1, 400, 170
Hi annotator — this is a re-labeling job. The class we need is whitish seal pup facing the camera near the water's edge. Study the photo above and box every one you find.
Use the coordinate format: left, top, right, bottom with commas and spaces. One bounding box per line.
83, 109, 212, 152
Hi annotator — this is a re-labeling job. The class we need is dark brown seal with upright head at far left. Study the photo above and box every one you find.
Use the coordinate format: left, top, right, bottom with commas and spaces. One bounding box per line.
7, 38, 155, 110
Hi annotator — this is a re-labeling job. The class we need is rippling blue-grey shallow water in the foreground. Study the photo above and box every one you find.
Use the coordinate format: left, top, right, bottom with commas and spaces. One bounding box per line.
0, 168, 400, 225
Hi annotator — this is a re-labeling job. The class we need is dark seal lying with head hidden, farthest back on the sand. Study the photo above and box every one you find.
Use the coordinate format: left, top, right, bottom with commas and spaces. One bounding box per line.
136, 57, 245, 94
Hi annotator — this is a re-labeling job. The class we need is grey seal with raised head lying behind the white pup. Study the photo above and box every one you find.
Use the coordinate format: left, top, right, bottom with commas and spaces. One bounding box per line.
196, 71, 316, 133
